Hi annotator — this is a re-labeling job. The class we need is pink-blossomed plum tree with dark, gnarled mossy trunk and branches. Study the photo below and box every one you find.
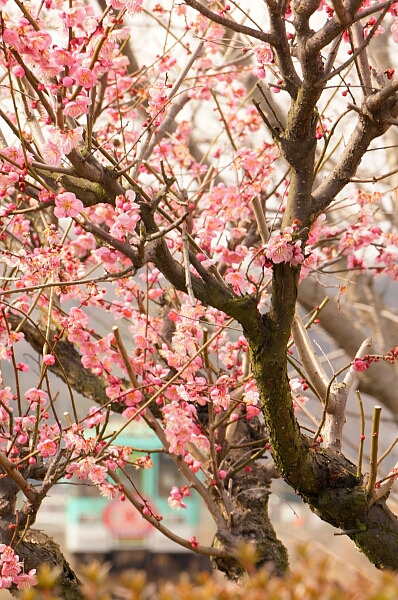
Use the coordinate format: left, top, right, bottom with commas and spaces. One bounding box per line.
0, 0, 398, 598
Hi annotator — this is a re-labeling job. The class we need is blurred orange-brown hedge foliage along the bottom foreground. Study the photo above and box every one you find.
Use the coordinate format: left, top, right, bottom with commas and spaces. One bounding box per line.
11, 546, 398, 600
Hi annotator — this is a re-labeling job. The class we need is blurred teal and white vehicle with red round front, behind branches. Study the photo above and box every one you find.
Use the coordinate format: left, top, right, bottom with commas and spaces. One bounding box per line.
65, 421, 214, 574
